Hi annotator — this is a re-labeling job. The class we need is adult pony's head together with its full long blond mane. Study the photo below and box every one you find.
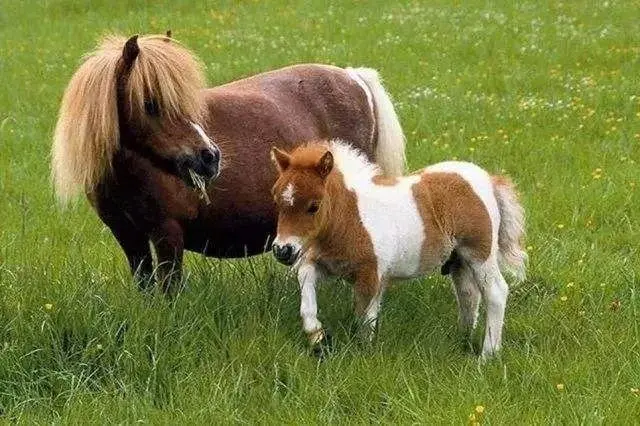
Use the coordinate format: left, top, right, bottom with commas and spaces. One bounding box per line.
52, 36, 220, 200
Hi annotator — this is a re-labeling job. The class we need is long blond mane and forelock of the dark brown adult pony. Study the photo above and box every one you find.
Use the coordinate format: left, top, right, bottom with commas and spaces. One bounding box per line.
52, 36, 205, 202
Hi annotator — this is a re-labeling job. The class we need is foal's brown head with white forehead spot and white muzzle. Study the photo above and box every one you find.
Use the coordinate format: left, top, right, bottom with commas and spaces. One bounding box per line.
271, 144, 333, 265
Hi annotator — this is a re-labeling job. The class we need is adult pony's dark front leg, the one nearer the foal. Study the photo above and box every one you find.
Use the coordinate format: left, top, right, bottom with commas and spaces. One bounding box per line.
151, 220, 184, 296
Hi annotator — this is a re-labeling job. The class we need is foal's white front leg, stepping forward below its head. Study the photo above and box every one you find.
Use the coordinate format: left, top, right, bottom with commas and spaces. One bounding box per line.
298, 263, 326, 347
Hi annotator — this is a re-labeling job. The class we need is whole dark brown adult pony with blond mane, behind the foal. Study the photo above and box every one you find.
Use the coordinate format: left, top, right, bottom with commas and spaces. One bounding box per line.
52, 36, 404, 291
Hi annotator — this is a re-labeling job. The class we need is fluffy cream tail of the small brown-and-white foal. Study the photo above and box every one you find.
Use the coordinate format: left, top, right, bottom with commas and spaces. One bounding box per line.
492, 176, 528, 281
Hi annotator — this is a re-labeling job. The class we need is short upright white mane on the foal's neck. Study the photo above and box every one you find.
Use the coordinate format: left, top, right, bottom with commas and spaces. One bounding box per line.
329, 139, 382, 188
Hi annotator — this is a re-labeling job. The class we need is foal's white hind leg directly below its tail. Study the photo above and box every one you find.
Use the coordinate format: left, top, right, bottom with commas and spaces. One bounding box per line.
471, 256, 509, 358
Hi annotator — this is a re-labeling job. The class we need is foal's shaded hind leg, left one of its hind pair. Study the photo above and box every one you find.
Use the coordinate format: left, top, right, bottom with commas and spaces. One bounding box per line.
451, 261, 481, 338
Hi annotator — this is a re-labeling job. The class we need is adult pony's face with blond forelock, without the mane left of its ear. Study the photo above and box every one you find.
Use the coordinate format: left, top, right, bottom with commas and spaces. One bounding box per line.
116, 36, 220, 185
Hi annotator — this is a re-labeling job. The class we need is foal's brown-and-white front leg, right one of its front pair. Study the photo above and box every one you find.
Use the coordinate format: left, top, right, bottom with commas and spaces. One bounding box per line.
354, 267, 384, 341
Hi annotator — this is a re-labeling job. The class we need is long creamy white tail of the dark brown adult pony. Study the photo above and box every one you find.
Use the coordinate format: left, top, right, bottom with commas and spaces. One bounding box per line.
347, 68, 406, 176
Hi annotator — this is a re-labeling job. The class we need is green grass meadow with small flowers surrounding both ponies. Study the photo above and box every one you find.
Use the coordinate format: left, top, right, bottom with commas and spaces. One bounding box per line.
0, 0, 640, 424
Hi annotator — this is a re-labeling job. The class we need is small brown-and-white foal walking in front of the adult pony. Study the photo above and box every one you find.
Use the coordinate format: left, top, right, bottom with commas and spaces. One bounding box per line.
272, 140, 526, 357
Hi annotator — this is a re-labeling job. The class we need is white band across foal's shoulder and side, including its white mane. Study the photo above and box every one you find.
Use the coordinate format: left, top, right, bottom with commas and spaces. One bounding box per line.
331, 141, 424, 278
